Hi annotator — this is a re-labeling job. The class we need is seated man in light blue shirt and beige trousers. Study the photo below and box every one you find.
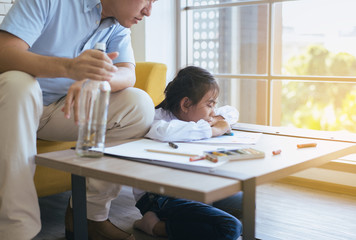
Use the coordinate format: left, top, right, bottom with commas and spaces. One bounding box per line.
0, 0, 154, 240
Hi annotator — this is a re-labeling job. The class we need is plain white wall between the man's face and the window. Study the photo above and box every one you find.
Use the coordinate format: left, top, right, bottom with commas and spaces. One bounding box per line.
131, 0, 176, 81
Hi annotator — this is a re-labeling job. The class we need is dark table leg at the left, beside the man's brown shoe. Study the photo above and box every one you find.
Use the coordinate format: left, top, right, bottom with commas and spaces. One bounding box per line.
72, 174, 88, 240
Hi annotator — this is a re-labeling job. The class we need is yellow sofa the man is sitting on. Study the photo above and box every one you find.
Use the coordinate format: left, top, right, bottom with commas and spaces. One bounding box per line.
34, 62, 167, 197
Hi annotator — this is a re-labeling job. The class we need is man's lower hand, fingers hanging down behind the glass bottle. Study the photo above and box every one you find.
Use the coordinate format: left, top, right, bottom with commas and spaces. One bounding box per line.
62, 80, 85, 125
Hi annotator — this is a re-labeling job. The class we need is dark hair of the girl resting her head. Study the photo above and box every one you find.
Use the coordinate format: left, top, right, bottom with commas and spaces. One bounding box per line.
156, 66, 219, 114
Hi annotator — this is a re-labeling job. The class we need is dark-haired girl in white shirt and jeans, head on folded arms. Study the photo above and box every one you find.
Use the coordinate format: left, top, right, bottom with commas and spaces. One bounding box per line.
133, 66, 242, 240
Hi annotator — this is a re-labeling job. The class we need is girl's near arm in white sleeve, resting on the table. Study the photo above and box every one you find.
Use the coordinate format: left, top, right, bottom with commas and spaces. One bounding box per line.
146, 119, 212, 142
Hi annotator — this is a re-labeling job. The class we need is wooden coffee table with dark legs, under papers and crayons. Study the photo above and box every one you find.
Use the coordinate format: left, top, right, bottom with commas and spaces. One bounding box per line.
35, 126, 356, 240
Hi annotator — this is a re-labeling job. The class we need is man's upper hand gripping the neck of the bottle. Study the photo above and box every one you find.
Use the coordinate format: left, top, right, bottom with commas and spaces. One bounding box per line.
67, 49, 119, 81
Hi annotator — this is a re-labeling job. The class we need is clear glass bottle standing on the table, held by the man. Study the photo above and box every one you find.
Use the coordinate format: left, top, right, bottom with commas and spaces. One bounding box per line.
75, 43, 111, 157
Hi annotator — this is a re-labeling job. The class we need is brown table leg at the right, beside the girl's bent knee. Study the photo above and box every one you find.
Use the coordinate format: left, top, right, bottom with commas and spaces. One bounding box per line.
242, 178, 256, 240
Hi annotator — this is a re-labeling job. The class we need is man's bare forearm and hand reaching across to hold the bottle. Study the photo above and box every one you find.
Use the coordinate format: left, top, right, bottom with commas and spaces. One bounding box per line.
0, 31, 118, 81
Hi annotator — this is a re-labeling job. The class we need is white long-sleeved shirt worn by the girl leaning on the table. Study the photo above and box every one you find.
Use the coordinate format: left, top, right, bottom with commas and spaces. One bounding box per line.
132, 105, 239, 201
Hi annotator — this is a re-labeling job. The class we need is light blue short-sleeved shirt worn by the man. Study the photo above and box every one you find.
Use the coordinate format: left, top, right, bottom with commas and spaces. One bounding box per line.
0, 0, 135, 105
